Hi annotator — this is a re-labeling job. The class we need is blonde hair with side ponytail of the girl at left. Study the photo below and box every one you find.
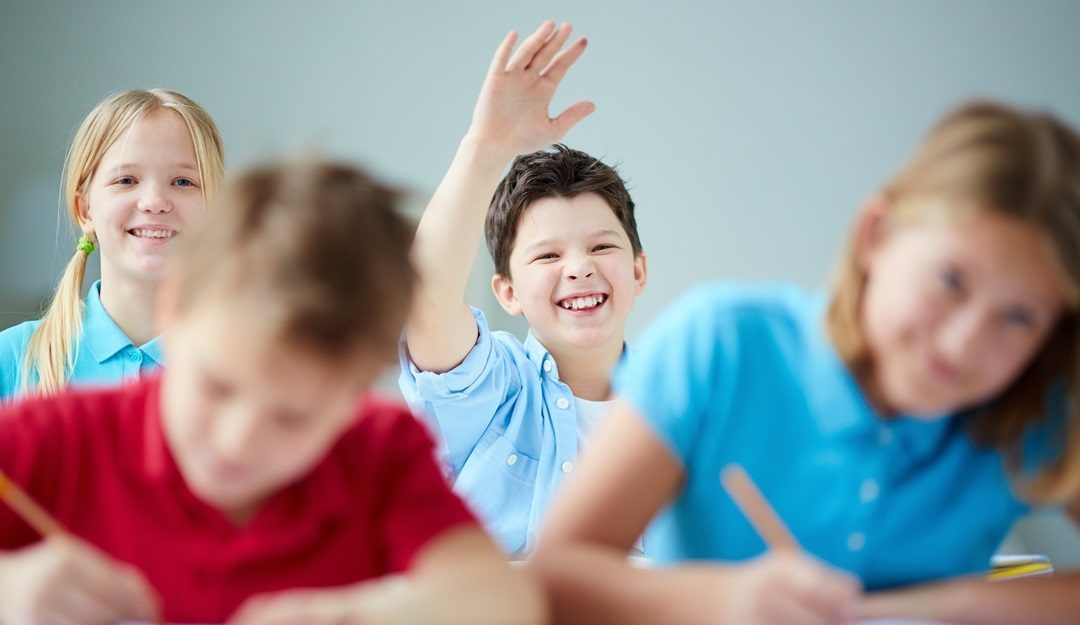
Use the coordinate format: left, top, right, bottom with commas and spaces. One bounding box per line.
22, 89, 225, 394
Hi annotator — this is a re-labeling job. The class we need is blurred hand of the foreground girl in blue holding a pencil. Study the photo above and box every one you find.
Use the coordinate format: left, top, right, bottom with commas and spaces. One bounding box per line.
717, 552, 861, 625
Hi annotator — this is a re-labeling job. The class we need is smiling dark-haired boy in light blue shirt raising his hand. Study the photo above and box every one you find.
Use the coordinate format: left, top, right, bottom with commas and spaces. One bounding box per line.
401, 22, 646, 555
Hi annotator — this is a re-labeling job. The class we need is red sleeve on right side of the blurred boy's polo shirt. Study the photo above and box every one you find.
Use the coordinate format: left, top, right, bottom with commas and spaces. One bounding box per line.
378, 412, 476, 572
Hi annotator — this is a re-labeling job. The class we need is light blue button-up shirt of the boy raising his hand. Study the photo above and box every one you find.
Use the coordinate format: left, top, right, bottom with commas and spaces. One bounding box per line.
400, 308, 625, 555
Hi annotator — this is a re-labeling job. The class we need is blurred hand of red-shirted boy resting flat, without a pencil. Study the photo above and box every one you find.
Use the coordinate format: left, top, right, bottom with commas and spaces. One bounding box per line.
229, 579, 408, 625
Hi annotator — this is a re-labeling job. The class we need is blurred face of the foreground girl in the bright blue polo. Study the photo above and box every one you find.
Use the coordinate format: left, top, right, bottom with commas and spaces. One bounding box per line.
860, 200, 1068, 417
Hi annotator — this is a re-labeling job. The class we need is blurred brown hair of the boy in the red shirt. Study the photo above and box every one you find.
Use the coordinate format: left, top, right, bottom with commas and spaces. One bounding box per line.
175, 162, 416, 363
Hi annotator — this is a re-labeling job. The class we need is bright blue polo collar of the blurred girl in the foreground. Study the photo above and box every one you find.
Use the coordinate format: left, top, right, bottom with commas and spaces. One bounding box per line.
804, 294, 961, 458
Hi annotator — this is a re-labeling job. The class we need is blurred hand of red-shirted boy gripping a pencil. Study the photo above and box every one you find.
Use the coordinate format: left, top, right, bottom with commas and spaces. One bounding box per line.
0, 538, 158, 625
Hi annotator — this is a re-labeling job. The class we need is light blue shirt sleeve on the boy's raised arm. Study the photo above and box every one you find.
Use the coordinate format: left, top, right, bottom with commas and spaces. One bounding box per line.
399, 308, 521, 475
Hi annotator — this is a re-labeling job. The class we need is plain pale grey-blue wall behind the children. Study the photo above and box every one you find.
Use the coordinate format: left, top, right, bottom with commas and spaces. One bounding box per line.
0, 0, 1080, 563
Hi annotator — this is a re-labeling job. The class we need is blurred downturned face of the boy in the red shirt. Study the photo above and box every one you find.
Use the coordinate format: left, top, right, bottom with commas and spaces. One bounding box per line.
161, 296, 379, 522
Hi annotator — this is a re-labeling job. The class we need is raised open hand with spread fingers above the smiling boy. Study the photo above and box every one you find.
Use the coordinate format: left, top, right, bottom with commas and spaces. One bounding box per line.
468, 22, 595, 160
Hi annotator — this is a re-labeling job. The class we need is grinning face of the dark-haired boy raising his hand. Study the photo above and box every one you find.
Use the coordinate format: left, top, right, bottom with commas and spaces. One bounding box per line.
491, 193, 646, 360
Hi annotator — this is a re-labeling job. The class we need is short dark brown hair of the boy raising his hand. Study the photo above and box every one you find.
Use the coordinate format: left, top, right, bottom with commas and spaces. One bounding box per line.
484, 144, 642, 277
